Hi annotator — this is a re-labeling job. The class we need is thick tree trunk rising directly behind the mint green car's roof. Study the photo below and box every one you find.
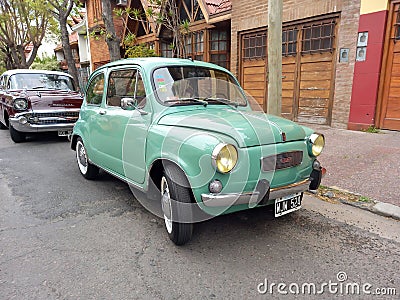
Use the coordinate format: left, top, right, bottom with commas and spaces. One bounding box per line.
101, 0, 121, 61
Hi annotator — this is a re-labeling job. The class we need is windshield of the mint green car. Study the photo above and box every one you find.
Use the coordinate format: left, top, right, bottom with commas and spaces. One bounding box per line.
153, 66, 247, 106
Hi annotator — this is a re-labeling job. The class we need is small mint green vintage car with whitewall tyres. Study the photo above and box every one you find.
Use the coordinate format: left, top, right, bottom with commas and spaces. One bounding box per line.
71, 58, 325, 245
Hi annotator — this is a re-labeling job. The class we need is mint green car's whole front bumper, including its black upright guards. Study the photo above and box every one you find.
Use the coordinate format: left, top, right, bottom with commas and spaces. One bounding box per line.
201, 168, 326, 207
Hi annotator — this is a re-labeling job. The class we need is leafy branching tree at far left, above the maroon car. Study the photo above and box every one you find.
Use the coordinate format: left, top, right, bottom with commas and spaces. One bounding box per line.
0, 0, 57, 69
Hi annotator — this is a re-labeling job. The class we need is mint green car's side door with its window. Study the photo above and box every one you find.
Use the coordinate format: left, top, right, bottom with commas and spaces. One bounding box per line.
93, 66, 151, 183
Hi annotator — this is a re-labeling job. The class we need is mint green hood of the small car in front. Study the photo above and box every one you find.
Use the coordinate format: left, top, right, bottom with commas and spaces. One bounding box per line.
158, 107, 306, 148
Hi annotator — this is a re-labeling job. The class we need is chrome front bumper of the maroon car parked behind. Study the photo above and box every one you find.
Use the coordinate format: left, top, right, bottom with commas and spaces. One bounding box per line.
9, 109, 79, 133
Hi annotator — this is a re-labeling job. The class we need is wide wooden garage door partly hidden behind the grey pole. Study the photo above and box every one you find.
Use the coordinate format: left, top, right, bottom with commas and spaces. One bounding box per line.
241, 18, 336, 125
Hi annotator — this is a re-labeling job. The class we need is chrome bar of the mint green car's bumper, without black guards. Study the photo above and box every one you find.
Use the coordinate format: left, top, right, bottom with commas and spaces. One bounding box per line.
201, 179, 311, 207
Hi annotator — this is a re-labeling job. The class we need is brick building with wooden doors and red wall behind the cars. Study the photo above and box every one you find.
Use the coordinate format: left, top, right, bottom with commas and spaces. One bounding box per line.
81, 0, 400, 130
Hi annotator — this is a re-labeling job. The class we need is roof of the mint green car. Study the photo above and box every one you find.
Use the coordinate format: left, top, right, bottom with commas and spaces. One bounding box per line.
96, 57, 229, 72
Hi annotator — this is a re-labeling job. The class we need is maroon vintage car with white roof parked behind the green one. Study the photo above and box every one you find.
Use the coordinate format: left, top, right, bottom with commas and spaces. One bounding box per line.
0, 69, 83, 143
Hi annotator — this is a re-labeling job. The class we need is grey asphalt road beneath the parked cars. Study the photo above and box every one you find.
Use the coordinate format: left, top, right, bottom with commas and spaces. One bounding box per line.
0, 130, 400, 299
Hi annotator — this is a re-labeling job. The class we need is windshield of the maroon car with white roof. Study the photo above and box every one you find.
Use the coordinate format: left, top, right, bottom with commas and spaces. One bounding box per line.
10, 73, 75, 90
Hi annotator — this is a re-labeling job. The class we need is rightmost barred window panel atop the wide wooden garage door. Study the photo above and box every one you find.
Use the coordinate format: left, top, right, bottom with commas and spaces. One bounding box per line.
302, 20, 335, 53
